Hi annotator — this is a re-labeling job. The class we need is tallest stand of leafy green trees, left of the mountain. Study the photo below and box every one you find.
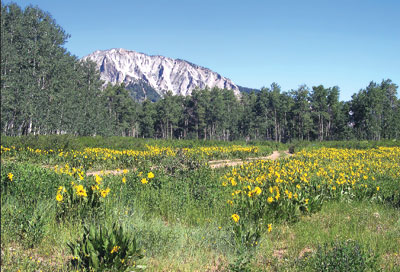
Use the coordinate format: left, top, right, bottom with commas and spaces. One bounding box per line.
0, 3, 108, 135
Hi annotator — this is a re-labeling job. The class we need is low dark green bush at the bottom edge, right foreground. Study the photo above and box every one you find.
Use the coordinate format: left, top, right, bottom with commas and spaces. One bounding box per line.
297, 240, 379, 272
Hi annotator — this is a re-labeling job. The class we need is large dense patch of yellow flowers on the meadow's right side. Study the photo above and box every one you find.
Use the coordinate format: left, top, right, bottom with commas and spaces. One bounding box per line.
222, 147, 400, 222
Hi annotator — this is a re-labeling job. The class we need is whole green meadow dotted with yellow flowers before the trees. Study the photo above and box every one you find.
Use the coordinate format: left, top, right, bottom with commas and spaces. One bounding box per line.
1, 136, 400, 271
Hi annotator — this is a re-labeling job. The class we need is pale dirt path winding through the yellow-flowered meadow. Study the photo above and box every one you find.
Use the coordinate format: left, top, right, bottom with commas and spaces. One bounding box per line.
86, 150, 292, 176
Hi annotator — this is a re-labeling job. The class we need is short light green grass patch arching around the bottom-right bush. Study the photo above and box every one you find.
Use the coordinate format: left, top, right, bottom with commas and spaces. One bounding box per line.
255, 202, 400, 271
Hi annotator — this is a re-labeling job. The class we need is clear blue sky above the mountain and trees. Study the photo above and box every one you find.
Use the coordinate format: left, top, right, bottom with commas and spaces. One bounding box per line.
3, 0, 400, 101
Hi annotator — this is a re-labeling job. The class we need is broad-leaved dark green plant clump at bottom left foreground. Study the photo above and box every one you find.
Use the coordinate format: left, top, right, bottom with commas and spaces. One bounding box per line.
68, 223, 143, 271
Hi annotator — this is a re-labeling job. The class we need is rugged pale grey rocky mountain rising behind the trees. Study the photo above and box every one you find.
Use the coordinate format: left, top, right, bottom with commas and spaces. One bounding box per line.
83, 48, 240, 100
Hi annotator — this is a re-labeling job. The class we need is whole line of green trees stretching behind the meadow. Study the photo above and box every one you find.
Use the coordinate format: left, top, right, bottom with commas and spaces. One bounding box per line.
1, 4, 400, 142
